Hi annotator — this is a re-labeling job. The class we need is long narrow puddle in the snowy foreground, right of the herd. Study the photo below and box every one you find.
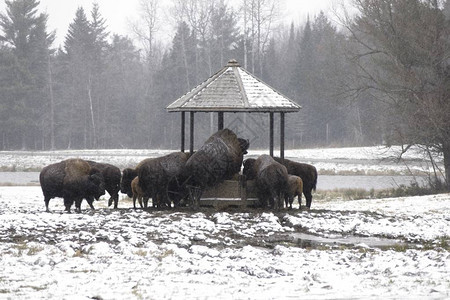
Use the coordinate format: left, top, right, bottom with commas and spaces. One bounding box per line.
290, 232, 406, 248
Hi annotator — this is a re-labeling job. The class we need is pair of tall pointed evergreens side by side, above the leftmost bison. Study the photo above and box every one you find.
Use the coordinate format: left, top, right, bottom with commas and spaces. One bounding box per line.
64, 4, 108, 148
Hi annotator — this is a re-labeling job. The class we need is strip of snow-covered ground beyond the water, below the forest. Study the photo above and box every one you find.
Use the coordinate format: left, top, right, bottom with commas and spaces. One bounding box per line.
0, 146, 442, 175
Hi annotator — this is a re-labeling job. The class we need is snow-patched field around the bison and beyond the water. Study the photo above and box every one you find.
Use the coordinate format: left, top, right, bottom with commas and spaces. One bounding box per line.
0, 149, 450, 299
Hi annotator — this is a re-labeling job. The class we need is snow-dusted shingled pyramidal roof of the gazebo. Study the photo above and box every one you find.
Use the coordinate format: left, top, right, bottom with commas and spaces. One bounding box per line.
166, 60, 301, 112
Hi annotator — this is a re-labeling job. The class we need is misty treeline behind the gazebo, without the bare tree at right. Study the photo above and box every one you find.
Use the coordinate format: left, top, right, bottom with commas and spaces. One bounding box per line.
0, 0, 362, 149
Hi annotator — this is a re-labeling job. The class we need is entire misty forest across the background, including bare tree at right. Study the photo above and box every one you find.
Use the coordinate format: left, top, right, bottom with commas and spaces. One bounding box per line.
0, 0, 450, 188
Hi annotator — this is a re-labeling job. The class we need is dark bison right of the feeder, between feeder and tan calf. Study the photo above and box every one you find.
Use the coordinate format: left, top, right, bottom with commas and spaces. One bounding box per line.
243, 155, 288, 210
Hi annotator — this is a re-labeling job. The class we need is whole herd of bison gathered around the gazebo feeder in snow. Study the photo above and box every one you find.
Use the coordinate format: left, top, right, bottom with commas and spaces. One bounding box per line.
39, 129, 317, 212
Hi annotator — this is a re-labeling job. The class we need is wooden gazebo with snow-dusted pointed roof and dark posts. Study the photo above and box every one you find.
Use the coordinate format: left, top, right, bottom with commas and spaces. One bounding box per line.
166, 60, 301, 158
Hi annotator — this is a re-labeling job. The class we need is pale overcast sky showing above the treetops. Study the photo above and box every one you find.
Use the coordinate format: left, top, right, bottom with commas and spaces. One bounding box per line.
0, 0, 338, 46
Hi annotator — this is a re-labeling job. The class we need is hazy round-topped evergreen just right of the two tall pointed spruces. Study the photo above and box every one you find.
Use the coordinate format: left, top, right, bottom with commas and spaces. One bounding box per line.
102, 35, 144, 148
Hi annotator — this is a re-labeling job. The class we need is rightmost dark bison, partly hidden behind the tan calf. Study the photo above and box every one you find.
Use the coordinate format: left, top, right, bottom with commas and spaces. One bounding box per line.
275, 157, 317, 209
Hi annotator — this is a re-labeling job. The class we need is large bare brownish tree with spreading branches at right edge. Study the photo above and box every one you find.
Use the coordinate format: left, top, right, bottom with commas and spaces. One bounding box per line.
347, 0, 450, 190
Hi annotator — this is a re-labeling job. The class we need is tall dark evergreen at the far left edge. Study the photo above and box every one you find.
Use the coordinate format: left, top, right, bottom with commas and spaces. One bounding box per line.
0, 0, 54, 149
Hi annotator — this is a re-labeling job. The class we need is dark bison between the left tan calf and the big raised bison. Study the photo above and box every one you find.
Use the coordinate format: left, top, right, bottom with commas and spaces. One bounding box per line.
137, 152, 189, 208
